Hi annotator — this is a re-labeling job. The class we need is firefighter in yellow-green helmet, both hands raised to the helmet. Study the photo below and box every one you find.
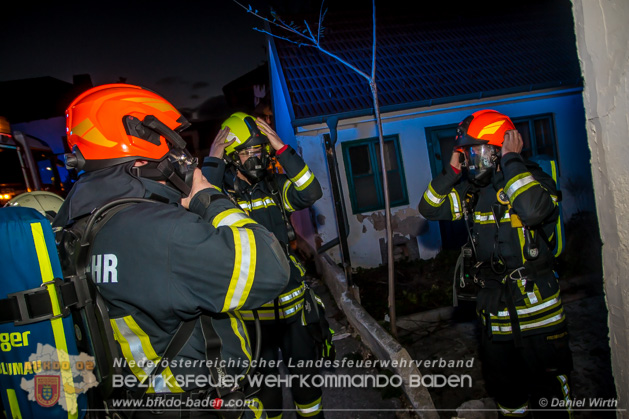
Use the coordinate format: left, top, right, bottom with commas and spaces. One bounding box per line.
203, 112, 333, 418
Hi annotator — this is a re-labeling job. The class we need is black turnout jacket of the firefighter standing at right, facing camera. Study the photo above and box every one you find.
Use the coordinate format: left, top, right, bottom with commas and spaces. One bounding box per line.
419, 153, 565, 340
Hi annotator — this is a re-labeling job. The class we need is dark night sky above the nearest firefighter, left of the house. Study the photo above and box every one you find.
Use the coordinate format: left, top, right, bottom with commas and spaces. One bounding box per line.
0, 0, 268, 108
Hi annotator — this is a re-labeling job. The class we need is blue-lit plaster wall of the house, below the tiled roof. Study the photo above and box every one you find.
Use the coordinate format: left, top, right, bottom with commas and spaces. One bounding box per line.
296, 89, 593, 267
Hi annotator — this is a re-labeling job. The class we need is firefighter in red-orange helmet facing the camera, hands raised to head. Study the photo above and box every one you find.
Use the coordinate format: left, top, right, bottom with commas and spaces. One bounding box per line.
419, 109, 572, 418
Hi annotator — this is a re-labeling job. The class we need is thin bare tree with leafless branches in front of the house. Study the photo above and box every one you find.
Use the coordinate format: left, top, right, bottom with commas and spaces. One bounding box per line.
233, 0, 397, 338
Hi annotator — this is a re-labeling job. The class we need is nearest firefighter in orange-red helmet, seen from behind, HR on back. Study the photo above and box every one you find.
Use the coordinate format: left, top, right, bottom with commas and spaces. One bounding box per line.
53, 84, 290, 418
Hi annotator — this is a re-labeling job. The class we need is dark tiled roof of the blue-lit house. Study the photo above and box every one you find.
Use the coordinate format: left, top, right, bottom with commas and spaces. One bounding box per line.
274, 0, 582, 123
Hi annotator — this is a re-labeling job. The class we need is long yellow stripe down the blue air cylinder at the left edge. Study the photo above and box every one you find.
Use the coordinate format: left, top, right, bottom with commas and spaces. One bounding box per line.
31, 223, 79, 418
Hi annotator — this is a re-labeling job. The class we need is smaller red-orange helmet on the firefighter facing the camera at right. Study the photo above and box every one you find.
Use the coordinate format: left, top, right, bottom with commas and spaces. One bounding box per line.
454, 109, 515, 148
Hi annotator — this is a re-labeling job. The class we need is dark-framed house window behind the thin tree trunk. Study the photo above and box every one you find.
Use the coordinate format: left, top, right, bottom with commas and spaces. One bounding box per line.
342, 135, 408, 214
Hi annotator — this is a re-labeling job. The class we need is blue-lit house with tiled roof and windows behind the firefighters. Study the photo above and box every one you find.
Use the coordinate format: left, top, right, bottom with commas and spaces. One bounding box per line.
269, 3, 594, 267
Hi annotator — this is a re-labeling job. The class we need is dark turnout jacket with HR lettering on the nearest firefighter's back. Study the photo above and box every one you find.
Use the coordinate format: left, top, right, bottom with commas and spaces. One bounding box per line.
54, 163, 290, 393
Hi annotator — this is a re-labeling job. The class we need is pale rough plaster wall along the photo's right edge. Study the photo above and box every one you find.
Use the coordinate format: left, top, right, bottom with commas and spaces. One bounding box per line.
573, 0, 629, 418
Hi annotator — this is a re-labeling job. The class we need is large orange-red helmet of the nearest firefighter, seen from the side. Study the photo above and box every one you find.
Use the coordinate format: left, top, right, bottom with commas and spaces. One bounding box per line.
66, 84, 189, 171
